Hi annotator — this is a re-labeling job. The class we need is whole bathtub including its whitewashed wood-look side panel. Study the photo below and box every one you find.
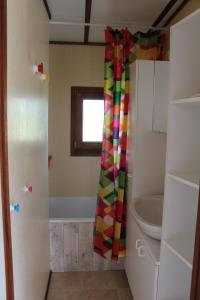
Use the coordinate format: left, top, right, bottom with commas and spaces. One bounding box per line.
49, 196, 124, 272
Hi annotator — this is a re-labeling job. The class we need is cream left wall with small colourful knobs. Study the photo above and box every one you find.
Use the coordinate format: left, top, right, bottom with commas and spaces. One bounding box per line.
7, 0, 49, 300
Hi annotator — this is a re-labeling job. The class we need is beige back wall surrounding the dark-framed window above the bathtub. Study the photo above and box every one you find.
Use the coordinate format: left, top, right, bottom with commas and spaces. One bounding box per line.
49, 45, 104, 196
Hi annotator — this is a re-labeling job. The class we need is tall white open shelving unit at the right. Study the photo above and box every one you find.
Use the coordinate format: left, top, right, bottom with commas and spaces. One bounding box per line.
158, 10, 200, 300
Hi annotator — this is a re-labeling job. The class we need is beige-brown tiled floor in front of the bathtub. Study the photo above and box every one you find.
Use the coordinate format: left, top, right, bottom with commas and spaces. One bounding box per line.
48, 271, 133, 300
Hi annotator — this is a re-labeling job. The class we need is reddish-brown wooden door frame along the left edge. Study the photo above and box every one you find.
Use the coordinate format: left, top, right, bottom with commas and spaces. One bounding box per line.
0, 0, 14, 300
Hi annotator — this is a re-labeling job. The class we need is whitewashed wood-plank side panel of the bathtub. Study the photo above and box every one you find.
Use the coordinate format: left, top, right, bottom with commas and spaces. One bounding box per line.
49, 218, 124, 272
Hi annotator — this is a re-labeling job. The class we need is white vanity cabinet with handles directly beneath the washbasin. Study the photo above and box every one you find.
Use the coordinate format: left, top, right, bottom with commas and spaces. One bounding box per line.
125, 215, 158, 300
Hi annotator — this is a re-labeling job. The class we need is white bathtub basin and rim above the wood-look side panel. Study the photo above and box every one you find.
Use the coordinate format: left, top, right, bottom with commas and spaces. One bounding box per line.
49, 196, 97, 222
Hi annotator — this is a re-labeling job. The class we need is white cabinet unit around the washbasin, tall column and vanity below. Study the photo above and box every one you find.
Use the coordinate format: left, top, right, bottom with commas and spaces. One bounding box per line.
125, 60, 168, 300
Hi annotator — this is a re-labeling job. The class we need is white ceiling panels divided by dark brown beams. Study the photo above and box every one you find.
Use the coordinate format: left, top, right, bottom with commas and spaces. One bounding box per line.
44, 0, 182, 43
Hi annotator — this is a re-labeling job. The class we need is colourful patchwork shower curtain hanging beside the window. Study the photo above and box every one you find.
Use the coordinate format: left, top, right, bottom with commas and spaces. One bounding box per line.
94, 28, 165, 260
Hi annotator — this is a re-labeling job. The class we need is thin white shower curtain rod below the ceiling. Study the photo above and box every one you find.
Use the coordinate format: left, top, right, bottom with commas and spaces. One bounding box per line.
49, 21, 167, 30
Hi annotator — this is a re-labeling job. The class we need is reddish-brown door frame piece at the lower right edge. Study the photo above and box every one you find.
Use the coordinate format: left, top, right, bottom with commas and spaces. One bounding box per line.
190, 185, 200, 300
